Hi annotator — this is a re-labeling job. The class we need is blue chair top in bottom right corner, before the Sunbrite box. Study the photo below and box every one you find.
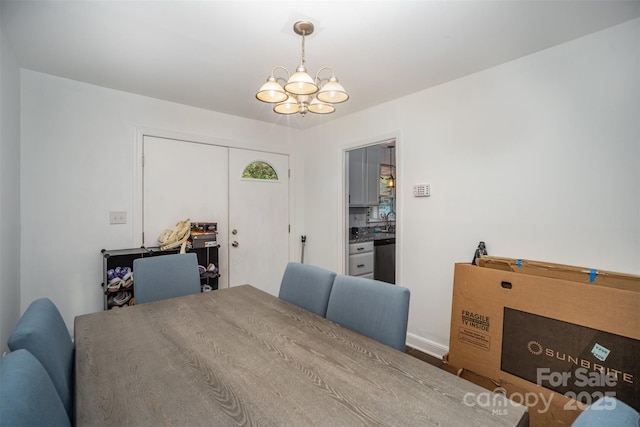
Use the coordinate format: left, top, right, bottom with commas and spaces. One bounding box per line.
571, 396, 640, 427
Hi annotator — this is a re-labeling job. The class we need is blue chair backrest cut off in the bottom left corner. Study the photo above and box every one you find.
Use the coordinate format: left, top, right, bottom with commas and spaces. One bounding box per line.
0, 350, 71, 427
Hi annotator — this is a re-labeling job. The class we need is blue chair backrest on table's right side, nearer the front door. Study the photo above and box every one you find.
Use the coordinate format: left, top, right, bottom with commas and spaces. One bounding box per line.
278, 262, 336, 317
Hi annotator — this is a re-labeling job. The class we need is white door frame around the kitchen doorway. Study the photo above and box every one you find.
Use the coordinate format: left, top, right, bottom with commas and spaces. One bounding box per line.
338, 131, 404, 283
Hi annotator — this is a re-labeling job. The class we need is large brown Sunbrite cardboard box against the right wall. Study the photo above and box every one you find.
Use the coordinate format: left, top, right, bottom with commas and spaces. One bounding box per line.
448, 257, 640, 425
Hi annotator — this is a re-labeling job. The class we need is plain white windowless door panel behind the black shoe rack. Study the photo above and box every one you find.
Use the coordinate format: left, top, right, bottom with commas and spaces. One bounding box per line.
142, 136, 229, 288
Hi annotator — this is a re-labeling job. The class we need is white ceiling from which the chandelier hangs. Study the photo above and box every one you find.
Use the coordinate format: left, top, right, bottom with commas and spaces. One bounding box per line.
0, 0, 640, 128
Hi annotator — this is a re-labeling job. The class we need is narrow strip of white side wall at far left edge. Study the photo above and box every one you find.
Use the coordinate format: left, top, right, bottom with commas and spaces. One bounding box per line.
0, 13, 20, 354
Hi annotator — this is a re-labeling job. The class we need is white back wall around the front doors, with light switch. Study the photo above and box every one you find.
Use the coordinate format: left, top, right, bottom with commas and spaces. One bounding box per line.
19, 70, 299, 329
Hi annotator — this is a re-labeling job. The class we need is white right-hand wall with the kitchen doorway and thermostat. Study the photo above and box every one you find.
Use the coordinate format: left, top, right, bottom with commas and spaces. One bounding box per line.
304, 19, 640, 355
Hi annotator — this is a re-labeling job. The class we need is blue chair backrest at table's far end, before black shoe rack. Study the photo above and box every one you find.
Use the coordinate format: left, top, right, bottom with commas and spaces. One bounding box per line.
133, 253, 200, 304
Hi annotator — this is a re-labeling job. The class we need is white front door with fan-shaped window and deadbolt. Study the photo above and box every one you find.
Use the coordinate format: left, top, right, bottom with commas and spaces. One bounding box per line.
228, 148, 289, 295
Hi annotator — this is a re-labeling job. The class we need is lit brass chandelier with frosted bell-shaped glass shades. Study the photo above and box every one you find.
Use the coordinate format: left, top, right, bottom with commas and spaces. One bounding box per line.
256, 21, 349, 116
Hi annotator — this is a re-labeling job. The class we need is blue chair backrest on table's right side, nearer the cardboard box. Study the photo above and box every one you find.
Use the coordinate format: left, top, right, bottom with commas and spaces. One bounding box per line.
327, 275, 410, 351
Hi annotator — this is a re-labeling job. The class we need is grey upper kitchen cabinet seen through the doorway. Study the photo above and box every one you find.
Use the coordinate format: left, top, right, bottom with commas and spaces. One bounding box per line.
349, 146, 382, 206
